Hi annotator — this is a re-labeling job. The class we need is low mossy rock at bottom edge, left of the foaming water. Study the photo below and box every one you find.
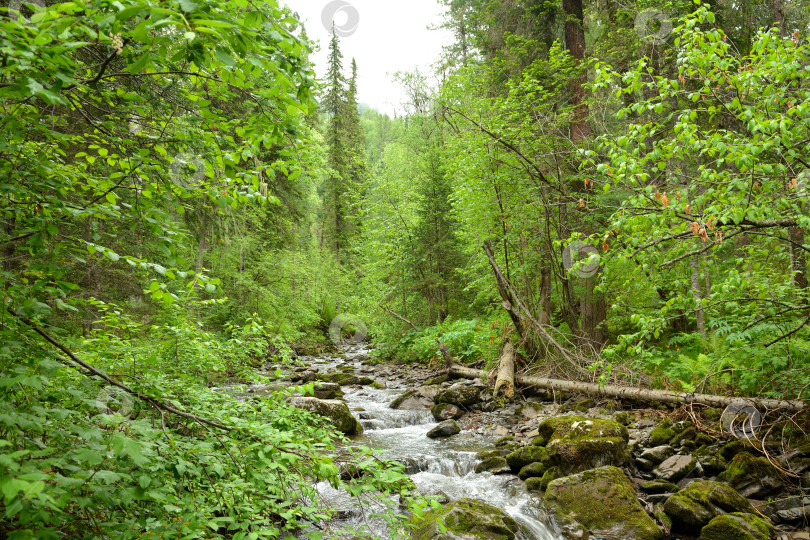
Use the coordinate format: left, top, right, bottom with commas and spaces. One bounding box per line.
409, 499, 520, 540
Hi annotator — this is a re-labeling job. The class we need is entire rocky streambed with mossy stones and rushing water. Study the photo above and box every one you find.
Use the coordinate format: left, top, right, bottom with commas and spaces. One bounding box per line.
276, 347, 810, 540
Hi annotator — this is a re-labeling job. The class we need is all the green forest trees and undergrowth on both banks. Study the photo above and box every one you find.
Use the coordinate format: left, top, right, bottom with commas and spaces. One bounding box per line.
0, 0, 810, 539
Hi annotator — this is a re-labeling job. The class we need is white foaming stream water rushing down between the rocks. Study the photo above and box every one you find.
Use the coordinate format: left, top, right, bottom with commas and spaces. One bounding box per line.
306, 349, 560, 540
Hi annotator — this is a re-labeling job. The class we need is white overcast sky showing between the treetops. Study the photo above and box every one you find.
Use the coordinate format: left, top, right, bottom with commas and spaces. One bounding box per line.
284, 0, 452, 116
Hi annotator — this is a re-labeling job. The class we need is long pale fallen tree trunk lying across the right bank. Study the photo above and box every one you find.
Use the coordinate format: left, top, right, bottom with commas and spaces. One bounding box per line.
450, 364, 805, 412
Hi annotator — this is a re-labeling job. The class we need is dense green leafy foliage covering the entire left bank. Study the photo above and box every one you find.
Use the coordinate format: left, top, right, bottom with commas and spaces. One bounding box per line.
0, 0, 422, 538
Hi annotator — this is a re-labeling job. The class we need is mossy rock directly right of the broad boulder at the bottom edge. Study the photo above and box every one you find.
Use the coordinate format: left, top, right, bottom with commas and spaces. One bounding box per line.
664, 480, 754, 534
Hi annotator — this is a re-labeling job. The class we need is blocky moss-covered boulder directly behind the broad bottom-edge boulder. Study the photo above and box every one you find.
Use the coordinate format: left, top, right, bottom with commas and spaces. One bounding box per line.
533, 416, 629, 474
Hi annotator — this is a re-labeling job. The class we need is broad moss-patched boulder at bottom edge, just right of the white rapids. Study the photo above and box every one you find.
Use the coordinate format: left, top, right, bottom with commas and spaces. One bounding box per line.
543, 466, 664, 540
